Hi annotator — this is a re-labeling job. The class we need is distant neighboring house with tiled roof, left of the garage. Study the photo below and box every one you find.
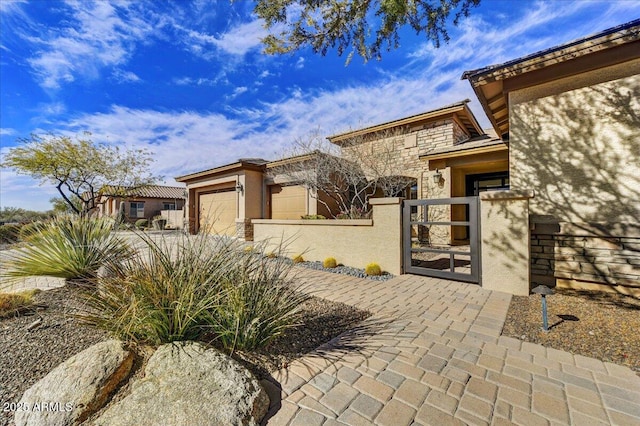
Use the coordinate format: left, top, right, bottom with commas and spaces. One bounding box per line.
98, 185, 186, 228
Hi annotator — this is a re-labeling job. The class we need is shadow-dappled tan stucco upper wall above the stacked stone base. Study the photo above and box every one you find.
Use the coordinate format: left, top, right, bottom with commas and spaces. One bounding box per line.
509, 59, 640, 222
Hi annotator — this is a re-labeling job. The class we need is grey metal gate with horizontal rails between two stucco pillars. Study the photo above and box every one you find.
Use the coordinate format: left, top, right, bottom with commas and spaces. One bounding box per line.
402, 197, 480, 283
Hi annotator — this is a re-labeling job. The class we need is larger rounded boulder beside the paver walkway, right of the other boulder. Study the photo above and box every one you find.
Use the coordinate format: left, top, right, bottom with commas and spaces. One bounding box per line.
95, 342, 269, 426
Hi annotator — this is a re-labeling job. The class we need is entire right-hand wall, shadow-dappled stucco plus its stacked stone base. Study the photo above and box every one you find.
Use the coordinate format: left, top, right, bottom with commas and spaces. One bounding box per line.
509, 60, 640, 293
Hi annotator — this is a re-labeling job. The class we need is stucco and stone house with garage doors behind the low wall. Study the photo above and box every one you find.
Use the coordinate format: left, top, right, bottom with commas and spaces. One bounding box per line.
176, 100, 496, 240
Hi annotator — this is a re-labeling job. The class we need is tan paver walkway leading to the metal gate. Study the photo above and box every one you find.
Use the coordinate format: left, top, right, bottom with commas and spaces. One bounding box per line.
266, 270, 640, 426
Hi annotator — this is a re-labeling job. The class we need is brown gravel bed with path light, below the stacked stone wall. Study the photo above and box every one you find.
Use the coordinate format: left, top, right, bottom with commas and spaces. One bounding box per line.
502, 289, 640, 375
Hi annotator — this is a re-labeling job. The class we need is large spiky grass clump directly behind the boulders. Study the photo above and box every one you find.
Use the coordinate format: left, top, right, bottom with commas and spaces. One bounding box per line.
80, 235, 305, 352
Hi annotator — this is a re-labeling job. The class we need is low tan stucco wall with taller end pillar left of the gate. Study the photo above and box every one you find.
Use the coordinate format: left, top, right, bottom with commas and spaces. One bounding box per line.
252, 198, 402, 275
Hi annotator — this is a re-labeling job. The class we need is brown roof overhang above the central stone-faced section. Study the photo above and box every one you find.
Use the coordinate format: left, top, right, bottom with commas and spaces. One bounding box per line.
327, 99, 484, 145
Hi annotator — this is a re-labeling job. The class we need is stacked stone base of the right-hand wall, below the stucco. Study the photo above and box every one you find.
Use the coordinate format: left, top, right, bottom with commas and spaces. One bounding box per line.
531, 219, 640, 296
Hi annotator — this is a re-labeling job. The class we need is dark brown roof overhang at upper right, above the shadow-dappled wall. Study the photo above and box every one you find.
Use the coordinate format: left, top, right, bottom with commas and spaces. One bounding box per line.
462, 20, 640, 139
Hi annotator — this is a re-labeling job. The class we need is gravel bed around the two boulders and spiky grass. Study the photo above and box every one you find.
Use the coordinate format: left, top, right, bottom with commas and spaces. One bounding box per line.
0, 287, 369, 426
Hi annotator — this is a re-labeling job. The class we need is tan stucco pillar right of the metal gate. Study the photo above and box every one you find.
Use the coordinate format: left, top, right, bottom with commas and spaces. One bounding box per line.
480, 191, 533, 296
